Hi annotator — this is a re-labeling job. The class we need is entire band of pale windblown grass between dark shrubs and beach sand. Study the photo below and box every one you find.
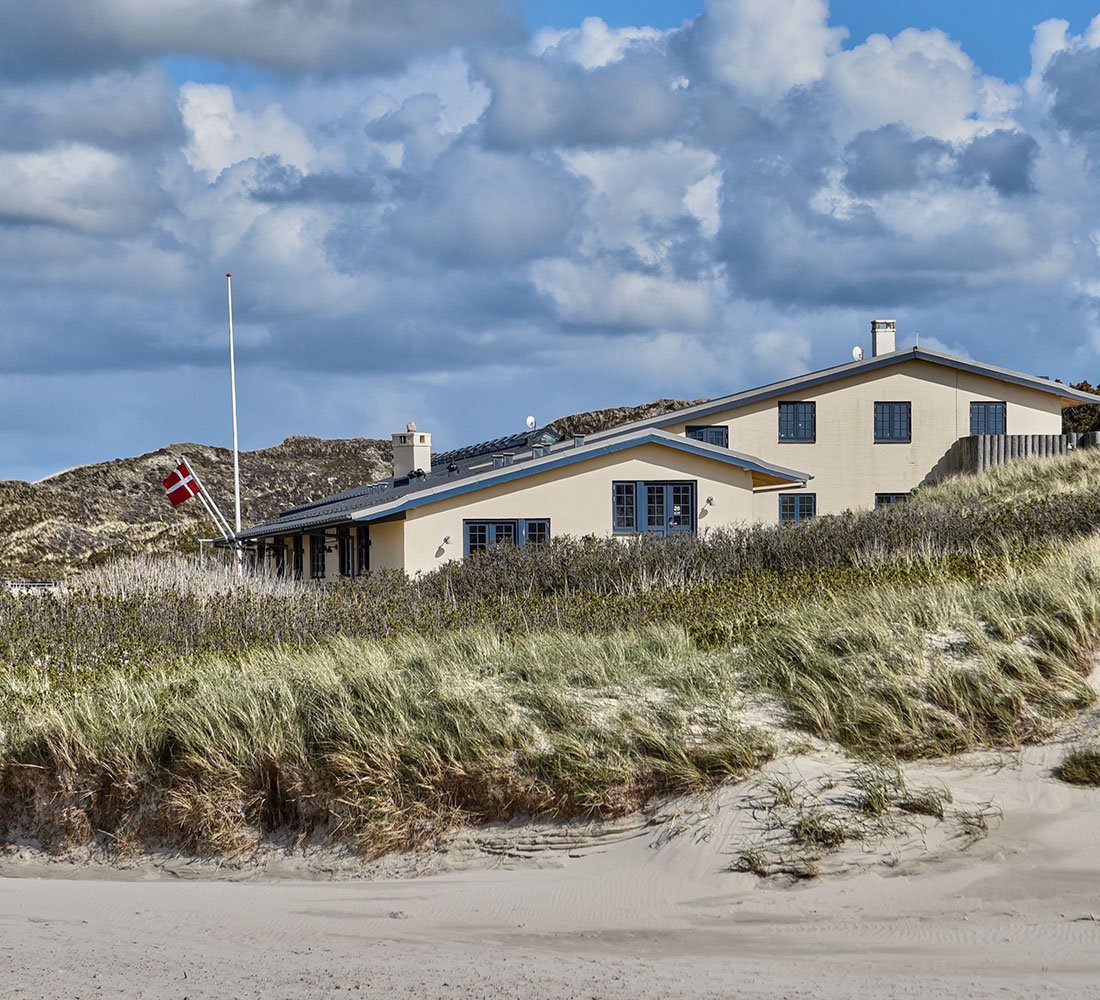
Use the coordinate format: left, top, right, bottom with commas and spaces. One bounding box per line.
0, 539, 1100, 855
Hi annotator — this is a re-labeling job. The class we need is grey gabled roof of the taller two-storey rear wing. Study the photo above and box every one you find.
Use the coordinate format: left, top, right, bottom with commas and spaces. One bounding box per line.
590, 348, 1100, 440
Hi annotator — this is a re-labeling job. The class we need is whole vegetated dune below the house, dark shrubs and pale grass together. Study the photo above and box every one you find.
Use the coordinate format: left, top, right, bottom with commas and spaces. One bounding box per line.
0, 453, 1100, 855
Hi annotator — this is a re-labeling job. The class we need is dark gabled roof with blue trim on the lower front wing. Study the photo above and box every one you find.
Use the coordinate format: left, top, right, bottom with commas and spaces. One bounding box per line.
237, 428, 812, 539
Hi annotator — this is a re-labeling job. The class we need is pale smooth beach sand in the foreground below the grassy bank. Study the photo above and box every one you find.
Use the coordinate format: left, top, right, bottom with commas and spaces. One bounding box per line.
0, 726, 1100, 1000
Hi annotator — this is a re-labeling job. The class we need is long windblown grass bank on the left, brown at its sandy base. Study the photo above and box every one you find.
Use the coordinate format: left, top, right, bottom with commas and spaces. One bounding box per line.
0, 629, 773, 855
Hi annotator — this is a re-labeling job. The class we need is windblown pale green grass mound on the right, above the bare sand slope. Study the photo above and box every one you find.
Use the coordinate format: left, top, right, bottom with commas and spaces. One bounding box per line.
749, 538, 1100, 757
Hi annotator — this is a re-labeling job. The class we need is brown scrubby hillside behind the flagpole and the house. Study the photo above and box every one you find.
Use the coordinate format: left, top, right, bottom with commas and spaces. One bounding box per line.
0, 399, 689, 579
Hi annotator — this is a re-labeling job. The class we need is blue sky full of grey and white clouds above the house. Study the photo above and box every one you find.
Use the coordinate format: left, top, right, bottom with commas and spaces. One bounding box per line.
0, 0, 1100, 480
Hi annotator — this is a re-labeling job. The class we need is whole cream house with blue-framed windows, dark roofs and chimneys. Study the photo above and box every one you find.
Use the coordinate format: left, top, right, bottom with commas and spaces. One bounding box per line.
241, 320, 1100, 578
